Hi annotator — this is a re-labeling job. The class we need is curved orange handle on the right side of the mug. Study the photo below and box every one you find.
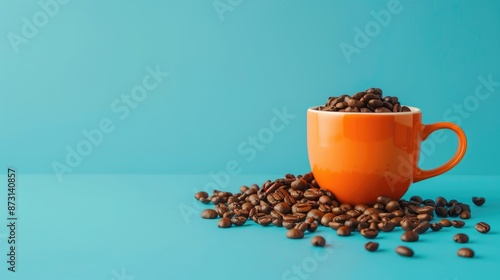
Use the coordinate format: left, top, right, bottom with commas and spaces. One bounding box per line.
413, 122, 467, 182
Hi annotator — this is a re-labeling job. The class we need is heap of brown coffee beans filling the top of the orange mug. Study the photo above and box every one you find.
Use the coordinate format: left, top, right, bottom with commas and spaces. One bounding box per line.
316, 88, 411, 113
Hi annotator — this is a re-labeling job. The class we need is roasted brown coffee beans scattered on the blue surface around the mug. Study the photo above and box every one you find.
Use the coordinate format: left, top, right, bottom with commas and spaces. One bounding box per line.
195, 173, 490, 257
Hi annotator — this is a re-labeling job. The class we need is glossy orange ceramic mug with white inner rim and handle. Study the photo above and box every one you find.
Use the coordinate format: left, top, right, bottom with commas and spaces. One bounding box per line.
307, 107, 467, 205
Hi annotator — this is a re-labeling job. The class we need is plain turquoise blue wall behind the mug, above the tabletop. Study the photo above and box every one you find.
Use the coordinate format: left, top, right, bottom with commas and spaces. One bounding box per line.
0, 0, 500, 175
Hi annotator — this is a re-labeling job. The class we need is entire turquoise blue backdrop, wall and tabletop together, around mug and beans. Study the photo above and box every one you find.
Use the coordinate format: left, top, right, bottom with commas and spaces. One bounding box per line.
0, 0, 500, 280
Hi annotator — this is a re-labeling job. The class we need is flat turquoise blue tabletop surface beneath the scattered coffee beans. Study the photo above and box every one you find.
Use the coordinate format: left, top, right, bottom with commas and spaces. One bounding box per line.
0, 174, 500, 280
